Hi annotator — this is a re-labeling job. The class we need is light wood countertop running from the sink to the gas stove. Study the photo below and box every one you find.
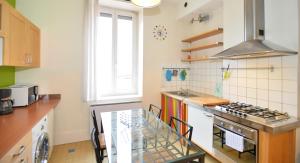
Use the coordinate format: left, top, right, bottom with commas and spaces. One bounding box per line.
161, 91, 230, 106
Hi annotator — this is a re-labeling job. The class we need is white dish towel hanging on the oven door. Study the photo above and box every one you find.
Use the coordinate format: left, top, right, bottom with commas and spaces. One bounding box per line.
225, 131, 244, 152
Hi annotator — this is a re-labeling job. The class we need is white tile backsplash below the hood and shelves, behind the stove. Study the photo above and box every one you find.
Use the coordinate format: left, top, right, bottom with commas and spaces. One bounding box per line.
166, 56, 298, 116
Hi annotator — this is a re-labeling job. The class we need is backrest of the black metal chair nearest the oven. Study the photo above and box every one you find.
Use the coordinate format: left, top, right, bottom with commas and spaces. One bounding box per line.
169, 116, 193, 141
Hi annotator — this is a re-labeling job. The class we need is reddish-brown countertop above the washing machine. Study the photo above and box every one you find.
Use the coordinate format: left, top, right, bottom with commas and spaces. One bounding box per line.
0, 94, 60, 158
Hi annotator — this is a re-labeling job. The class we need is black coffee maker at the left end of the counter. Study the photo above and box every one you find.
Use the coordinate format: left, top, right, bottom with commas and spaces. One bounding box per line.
0, 88, 13, 115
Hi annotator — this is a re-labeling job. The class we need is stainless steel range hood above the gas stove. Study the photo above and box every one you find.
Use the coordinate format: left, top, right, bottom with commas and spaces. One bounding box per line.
211, 0, 298, 59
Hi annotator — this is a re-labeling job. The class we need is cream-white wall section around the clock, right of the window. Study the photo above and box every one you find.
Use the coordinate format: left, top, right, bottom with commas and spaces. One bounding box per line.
143, 1, 186, 106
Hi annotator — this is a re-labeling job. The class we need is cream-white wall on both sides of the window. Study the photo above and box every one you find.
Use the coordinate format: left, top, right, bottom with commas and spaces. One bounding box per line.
16, 0, 185, 144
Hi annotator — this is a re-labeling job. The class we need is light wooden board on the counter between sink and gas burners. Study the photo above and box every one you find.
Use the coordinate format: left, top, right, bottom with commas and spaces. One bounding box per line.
188, 96, 229, 106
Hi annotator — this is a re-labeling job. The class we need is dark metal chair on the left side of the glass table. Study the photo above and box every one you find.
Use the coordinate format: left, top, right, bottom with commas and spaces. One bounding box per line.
92, 110, 107, 160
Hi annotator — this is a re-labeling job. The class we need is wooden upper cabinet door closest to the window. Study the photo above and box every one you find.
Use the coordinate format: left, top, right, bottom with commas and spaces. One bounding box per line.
25, 22, 40, 67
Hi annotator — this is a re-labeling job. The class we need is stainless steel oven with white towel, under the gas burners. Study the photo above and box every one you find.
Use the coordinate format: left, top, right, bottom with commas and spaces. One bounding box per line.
213, 116, 258, 163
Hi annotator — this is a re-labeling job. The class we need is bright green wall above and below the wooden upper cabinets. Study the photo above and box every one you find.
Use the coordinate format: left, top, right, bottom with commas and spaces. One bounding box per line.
0, 0, 16, 87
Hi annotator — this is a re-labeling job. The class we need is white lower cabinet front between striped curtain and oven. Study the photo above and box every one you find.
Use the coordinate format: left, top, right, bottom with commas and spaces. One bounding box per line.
188, 105, 213, 153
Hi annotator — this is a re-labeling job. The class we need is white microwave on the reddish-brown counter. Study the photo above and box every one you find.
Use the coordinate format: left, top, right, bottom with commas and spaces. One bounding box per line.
9, 84, 39, 107
